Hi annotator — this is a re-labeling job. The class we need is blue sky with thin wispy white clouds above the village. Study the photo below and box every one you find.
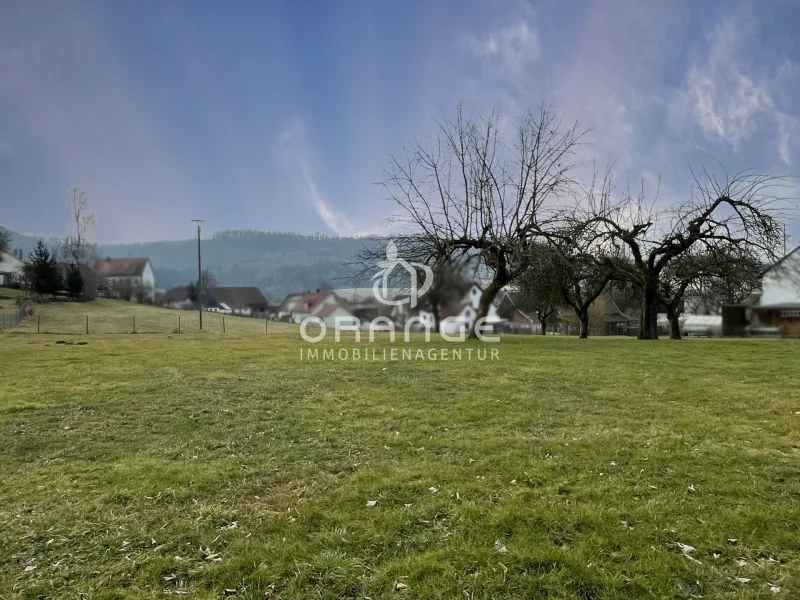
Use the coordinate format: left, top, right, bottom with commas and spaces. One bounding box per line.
0, 0, 800, 241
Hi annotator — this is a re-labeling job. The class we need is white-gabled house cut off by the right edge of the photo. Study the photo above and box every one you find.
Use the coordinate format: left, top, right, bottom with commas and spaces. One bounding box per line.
750, 246, 800, 337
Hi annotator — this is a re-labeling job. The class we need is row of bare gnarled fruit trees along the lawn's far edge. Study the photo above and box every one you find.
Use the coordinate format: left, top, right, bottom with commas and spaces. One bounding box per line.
361, 104, 787, 339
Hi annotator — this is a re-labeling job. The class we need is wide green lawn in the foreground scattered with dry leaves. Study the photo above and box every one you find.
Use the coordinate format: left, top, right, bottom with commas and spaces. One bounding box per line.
0, 333, 800, 600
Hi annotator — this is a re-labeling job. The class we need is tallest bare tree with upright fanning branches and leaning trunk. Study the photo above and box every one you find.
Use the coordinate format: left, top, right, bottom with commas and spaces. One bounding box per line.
372, 104, 583, 335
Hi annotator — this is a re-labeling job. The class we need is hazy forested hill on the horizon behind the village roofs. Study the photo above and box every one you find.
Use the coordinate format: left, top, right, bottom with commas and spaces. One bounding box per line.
0, 230, 367, 302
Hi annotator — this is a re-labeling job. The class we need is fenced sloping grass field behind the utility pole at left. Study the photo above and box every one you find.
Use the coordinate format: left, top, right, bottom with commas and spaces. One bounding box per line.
7, 298, 298, 335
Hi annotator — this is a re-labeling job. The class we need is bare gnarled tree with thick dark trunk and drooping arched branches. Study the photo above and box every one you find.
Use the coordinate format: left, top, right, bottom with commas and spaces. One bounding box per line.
584, 169, 786, 339
